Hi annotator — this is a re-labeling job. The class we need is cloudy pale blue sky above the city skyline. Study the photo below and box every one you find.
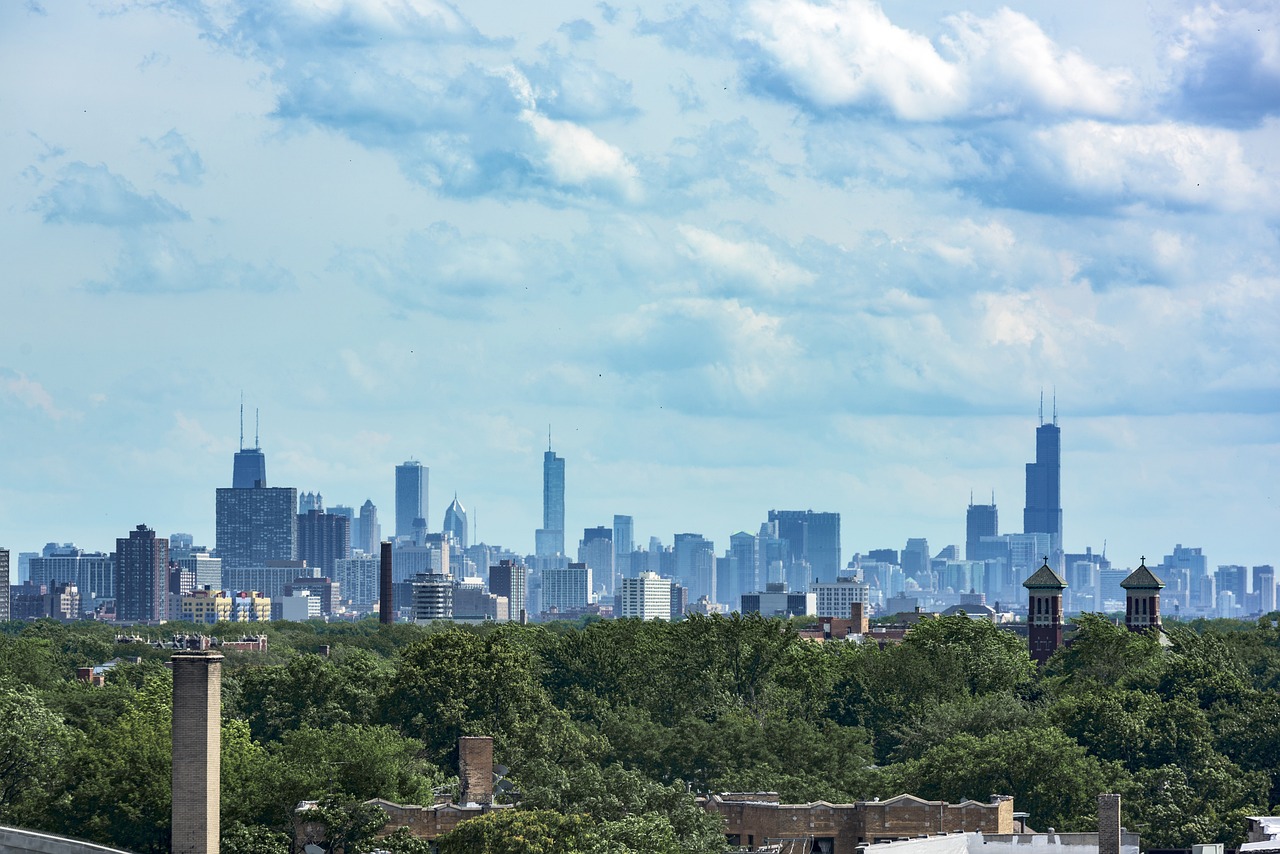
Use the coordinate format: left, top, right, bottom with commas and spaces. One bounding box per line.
0, 0, 1280, 567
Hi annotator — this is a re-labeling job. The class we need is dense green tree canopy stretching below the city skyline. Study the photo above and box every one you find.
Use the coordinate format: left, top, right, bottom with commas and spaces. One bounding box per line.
0, 615, 1280, 854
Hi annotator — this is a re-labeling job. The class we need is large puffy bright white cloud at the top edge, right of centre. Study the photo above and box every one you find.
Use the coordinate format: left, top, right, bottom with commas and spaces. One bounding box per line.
737, 0, 1135, 122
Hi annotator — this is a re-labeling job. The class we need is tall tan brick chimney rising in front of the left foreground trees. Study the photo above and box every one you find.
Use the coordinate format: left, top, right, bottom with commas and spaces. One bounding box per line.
172, 652, 223, 854
